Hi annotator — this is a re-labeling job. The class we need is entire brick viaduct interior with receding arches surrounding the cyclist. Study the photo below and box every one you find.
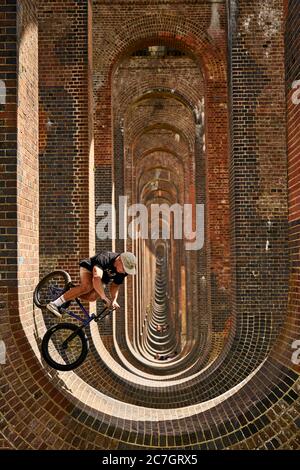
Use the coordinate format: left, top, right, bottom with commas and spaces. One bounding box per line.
0, 0, 300, 450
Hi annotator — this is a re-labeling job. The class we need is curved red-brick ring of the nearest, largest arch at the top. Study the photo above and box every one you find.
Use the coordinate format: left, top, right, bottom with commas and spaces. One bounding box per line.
93, 14, 226, 160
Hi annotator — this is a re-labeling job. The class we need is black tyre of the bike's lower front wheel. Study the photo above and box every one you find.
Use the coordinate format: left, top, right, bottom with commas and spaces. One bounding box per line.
41, 323, 89, 371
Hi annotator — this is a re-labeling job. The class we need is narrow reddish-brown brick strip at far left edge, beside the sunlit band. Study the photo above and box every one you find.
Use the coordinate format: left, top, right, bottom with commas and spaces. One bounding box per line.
0, 1, 18, 350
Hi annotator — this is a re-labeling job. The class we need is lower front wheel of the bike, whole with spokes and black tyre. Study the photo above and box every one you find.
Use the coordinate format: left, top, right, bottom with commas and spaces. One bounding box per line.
42, 323, 88, 371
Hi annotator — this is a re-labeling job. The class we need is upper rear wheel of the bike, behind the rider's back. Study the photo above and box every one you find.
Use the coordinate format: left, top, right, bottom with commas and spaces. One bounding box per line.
33, 270, 71, 308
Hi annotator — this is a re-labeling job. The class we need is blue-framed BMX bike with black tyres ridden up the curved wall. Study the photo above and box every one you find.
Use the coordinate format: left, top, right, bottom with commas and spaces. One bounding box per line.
33, 270, 115, 371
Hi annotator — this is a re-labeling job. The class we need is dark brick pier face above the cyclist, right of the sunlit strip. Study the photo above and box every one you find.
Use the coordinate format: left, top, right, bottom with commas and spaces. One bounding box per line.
38, 0, 93, 279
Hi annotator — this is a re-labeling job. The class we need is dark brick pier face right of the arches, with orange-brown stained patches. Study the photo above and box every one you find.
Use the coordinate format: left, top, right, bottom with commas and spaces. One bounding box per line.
230, 1, 288, 363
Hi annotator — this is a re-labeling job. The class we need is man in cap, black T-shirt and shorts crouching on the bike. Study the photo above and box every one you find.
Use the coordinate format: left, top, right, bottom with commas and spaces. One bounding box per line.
47, 251, 136, 317
